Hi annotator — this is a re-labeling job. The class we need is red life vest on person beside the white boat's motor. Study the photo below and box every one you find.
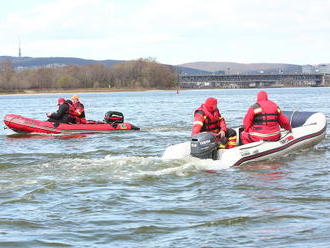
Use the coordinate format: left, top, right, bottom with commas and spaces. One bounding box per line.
195, 105, 223, 133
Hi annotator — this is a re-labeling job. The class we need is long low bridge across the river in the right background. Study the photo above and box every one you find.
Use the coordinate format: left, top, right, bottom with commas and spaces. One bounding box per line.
179, 73, 330, 88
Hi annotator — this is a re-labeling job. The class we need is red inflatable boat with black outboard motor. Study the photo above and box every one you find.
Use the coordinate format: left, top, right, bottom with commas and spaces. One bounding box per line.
4, 111, 140, 134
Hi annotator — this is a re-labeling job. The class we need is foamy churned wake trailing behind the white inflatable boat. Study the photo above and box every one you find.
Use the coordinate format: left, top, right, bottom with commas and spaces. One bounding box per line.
16, 155, 233, 181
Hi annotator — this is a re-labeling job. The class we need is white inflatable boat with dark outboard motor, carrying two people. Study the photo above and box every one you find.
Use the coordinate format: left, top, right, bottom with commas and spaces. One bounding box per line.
162, 111, 327, 167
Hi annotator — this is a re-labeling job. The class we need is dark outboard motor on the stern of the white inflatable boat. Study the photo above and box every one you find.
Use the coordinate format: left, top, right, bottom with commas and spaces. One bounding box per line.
190, 132, 218, 160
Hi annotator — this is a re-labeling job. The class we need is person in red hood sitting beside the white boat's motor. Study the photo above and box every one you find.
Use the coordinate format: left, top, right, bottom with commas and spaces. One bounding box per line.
191, 97, 236, 149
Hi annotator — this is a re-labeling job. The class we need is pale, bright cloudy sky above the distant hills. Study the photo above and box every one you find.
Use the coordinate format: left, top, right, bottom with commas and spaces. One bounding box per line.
0, 0, 330, 65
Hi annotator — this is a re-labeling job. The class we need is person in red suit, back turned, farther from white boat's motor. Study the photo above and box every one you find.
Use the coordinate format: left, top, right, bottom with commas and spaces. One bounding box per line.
241, 91, 292, 144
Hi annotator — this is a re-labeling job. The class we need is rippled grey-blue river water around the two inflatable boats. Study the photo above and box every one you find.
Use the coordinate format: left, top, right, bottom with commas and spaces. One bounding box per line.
0, 88, 330, 248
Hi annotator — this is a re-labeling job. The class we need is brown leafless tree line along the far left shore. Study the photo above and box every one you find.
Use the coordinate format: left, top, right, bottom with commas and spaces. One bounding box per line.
0, 59, 177, 91
